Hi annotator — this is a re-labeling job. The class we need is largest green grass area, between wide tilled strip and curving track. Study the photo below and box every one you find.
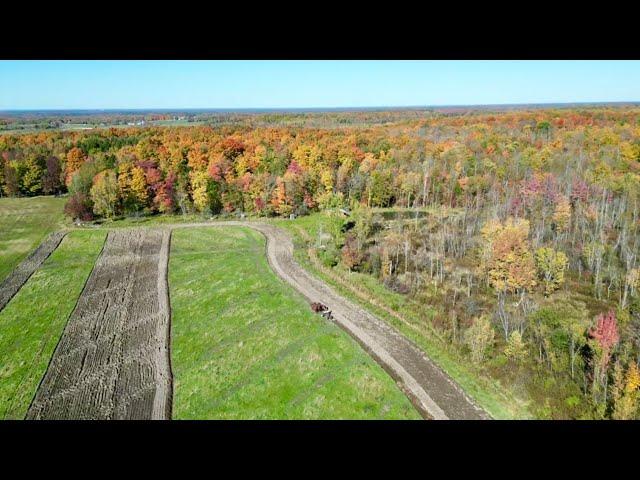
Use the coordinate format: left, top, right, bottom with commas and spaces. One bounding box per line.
169, 227, 420, 419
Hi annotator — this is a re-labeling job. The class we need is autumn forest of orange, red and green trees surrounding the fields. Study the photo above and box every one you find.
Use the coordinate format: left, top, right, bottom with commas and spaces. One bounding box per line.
0, 105, 640, 419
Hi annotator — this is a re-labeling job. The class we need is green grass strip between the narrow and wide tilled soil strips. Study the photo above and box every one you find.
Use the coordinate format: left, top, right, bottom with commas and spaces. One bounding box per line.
0, 231, 107, 419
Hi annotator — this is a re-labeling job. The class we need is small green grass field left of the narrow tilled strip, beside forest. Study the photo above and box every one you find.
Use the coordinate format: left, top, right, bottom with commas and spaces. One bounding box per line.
0, 197, 66, 282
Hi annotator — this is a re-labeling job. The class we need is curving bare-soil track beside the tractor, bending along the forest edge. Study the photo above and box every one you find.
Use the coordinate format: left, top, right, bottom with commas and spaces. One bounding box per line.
173, 221, 490, 420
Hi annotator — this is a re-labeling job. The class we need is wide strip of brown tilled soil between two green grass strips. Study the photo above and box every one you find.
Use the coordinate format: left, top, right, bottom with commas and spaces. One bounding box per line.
27, 229, 172, 419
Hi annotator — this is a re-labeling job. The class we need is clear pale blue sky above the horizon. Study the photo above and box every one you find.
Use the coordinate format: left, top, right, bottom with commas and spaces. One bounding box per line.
0, 60, 640, 110
